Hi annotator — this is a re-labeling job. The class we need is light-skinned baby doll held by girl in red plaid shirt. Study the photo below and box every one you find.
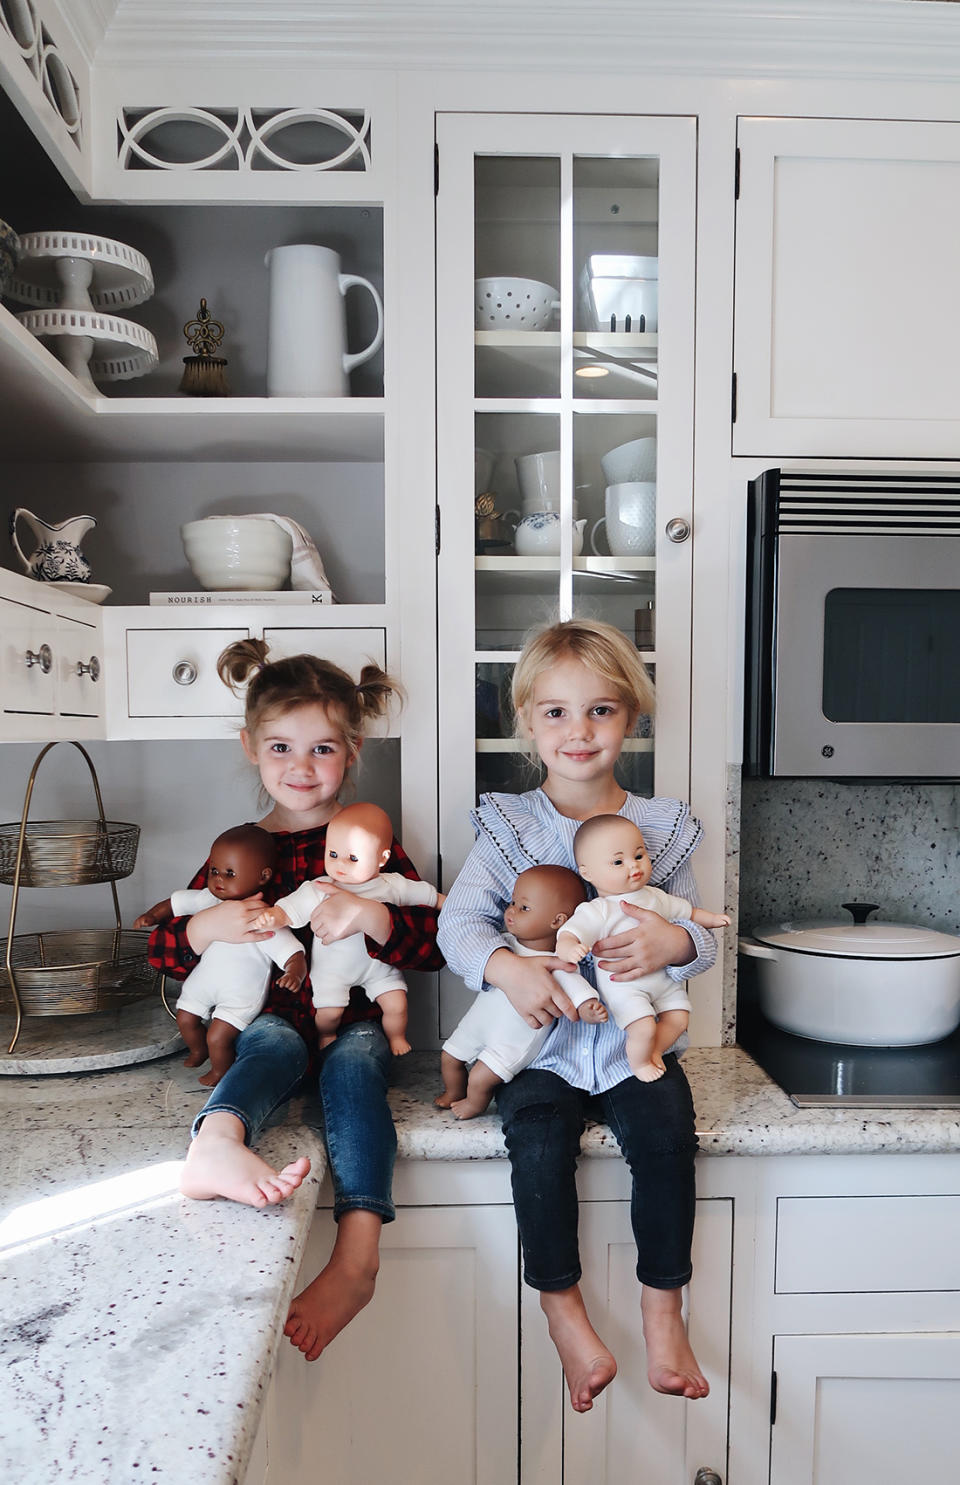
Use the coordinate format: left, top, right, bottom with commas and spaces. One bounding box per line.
253, 805, 443, 1056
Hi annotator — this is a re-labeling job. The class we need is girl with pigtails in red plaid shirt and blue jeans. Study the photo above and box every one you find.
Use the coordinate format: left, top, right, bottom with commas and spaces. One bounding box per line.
150, 640, 441, 1360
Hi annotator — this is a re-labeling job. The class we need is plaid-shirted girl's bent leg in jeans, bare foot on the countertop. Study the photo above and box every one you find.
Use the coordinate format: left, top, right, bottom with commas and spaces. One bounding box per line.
180, 1016, 311, 1207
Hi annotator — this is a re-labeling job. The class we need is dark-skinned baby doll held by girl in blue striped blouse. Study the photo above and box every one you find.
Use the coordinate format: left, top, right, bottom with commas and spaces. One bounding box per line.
434, 866, 606, 1118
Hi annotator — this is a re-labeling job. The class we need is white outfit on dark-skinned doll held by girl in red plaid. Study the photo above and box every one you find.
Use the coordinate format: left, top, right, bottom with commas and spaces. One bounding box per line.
169, 887, 303, 1031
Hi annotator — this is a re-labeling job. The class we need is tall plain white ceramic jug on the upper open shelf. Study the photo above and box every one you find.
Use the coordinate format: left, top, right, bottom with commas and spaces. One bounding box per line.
265, 242, 383, 396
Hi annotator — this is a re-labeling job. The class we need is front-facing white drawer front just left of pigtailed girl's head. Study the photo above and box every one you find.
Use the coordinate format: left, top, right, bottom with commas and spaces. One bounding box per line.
126, 627, 250, 717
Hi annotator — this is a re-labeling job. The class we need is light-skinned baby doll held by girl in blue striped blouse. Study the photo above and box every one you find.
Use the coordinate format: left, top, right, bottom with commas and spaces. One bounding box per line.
557, 815, 730, 1083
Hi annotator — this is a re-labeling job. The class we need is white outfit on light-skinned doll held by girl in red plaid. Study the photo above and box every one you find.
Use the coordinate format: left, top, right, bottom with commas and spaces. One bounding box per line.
276, 872, 437, 1010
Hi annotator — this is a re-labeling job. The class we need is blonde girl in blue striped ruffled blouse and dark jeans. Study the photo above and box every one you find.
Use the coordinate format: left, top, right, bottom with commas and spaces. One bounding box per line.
438, 619, 716, 1412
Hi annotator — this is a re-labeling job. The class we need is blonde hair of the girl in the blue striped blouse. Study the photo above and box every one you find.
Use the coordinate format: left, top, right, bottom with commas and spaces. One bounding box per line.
511, 619, 655, 735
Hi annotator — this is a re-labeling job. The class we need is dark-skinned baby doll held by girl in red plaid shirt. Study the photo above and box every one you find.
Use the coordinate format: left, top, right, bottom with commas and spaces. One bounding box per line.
134, 826, 306, 1087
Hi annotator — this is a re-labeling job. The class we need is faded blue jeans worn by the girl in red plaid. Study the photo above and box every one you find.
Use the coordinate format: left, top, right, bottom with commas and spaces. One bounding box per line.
192, 1014, 397, 1222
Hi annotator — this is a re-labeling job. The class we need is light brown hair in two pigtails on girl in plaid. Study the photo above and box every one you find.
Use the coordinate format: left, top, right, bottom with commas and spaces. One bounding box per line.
217, 640, 403, 763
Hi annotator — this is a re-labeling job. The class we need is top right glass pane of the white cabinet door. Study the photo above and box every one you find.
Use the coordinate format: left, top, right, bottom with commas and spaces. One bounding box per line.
574, 154, 660, 401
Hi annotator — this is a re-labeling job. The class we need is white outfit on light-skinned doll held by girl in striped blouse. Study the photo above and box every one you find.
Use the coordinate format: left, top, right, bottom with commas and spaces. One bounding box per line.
560, 887, 693, 1031
